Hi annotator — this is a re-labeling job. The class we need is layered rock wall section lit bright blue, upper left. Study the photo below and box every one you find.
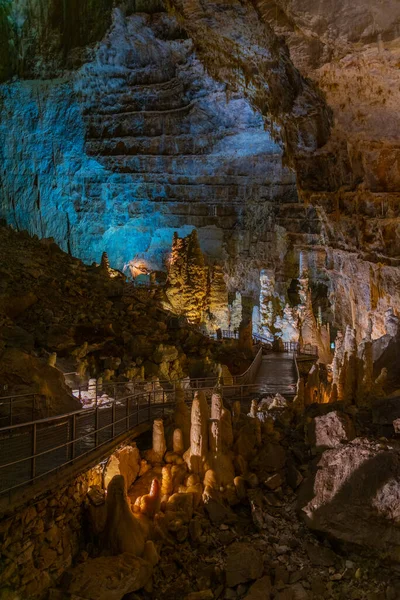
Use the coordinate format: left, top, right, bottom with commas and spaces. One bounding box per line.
0, 9, 297, 284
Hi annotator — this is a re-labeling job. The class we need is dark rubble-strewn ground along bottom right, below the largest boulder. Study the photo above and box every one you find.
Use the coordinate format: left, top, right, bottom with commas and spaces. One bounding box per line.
147, 488, 400, 600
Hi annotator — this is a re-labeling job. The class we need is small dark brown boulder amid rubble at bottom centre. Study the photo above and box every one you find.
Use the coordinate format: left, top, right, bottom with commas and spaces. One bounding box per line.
225, 542, 263, 587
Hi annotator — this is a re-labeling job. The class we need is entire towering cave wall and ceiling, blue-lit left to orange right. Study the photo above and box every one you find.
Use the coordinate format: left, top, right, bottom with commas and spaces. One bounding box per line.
0, 0, 400, 335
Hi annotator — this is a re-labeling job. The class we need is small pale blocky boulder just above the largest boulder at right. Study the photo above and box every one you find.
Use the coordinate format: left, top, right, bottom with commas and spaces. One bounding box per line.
307, 410, 356, 452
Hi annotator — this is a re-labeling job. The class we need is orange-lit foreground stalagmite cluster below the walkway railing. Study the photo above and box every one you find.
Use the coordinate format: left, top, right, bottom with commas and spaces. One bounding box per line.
79, 387, 276, 591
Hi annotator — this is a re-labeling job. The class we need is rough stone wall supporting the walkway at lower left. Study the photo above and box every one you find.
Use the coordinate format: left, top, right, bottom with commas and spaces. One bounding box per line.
0, 467, 101, 600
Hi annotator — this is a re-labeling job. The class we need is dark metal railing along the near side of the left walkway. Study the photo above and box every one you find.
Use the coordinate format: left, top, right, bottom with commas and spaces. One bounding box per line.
0, 384, 257, 495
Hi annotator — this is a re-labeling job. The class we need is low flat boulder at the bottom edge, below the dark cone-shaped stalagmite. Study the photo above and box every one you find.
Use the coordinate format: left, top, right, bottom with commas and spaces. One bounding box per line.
62, 553, 153, 600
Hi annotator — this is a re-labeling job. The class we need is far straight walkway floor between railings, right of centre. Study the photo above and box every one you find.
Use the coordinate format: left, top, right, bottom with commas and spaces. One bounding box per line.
254, 352, 297, 396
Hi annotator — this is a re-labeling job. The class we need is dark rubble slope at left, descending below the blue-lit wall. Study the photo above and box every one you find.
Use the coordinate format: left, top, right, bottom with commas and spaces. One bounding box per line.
0, 225, 216, 386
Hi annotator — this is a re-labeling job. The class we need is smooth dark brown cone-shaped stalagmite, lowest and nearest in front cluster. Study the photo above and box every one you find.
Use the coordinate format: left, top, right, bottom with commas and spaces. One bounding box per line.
104, 475, 145, 556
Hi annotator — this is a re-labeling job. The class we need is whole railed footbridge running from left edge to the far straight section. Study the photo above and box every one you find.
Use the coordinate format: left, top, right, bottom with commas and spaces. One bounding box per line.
0, 347, 318, 498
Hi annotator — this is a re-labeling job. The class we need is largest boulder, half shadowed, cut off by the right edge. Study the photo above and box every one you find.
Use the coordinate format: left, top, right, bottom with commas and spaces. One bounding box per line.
298, 438, 400, 561
